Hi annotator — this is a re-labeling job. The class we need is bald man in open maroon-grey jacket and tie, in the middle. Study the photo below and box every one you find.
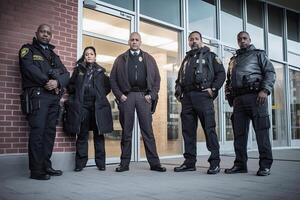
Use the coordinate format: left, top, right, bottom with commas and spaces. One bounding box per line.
110, 32, 166, 172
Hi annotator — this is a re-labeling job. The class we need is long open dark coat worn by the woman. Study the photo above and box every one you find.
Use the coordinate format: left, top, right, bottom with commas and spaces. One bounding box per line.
65, 63, 113, 134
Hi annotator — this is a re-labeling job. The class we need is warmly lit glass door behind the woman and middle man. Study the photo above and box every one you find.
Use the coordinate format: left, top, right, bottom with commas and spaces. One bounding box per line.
82, 5, 135, 164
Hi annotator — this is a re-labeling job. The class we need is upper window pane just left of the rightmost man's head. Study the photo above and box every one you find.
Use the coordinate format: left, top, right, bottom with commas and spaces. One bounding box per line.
221, 0, 243, 47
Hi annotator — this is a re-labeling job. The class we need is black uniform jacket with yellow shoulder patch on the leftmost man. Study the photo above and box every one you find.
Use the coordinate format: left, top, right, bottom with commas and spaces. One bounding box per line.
19, 38, 70, 89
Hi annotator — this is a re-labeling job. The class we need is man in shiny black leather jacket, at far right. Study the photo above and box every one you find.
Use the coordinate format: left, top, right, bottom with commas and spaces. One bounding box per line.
225, 31, 275, 176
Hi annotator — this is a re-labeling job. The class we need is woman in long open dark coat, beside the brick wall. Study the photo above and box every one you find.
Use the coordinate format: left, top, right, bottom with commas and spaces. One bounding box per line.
67, 46, 113, 172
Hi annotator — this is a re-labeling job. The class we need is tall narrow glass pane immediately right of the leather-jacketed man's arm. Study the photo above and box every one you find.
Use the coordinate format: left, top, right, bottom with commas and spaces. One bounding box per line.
272, 62, 287, 147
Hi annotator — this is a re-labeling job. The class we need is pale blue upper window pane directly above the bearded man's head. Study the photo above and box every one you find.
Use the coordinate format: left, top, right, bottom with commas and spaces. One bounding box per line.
188, 0, 216, 38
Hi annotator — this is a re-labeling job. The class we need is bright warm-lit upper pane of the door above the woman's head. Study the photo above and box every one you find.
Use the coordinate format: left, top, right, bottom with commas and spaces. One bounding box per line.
82, 8, 130, 41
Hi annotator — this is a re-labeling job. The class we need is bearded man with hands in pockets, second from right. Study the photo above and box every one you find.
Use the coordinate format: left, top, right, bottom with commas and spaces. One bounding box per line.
174, 31, 225, 174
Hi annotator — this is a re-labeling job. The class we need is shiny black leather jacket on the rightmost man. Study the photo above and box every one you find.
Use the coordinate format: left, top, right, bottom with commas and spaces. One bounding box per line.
225, 45, 276, 94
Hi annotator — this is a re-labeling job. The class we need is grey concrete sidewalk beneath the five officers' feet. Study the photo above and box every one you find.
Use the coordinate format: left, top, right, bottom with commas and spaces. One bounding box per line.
0, 149, 300, 200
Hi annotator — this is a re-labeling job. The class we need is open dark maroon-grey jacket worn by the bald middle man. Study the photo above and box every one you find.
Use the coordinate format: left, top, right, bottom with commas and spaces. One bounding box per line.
110, 50, 160, 100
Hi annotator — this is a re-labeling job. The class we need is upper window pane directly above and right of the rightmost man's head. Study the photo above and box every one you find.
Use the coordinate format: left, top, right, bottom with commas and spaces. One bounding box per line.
247, 0, 264, 49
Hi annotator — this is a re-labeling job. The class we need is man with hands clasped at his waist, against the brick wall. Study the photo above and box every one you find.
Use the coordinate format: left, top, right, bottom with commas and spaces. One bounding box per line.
19, 24, 69, 180
